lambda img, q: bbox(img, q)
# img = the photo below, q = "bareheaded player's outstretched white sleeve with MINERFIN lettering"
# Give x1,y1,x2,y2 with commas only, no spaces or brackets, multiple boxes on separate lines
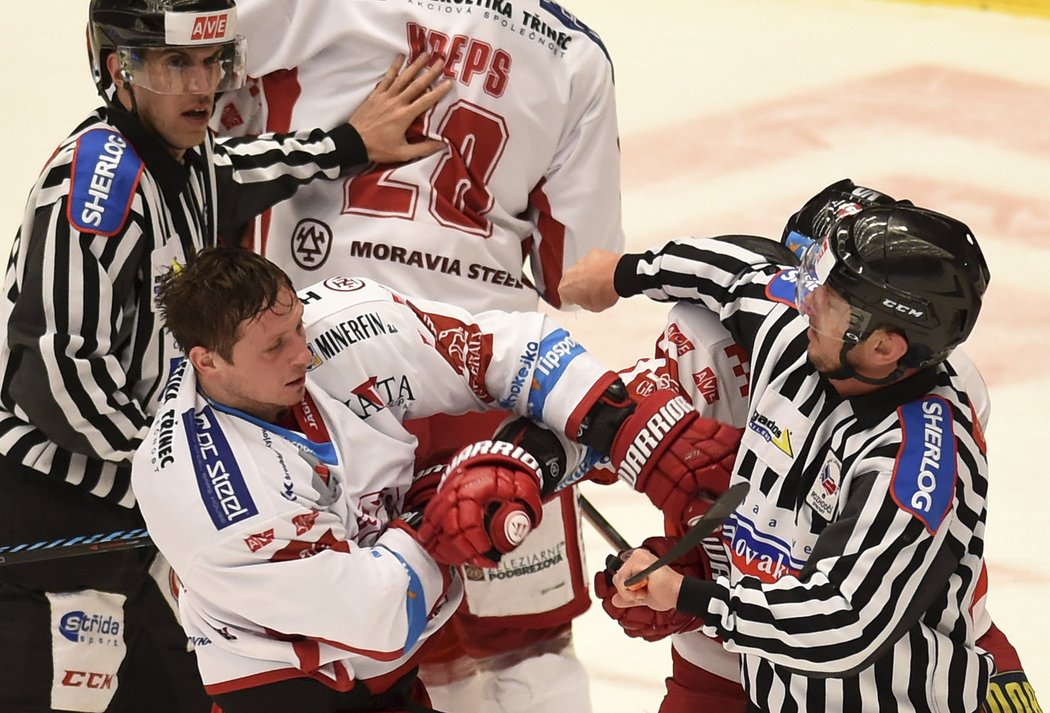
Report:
298,277,615,438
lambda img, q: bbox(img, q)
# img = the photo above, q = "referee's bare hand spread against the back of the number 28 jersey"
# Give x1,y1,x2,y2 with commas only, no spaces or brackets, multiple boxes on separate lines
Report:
350,53,453,164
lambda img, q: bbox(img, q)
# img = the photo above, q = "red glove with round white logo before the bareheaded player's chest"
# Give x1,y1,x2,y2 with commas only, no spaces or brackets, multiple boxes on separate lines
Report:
419,441,543,567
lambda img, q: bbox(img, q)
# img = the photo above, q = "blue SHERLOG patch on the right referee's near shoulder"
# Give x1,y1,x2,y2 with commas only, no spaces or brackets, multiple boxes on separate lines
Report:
890,395,958,533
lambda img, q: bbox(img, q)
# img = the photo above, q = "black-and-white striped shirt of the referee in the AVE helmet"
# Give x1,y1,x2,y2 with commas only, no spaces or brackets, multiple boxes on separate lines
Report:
0,108,366,507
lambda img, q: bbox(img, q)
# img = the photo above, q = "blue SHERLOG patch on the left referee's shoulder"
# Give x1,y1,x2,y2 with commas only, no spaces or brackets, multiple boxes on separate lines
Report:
67,129,144,237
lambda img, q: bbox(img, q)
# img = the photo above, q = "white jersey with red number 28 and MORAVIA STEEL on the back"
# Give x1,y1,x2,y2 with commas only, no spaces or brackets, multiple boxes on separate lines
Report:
213,0,624,312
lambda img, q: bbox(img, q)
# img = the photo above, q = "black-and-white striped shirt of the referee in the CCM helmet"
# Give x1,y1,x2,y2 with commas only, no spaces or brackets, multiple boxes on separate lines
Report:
616,238,991,713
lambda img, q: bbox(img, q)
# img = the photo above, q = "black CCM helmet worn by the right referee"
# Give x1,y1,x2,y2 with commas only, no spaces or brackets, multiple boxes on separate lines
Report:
814,203,990,368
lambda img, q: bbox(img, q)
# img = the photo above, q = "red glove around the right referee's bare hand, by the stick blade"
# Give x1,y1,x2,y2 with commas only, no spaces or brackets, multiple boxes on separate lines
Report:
594,538,711,642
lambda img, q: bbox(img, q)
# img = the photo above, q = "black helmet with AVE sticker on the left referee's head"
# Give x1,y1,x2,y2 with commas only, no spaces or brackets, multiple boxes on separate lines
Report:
87,0,245,101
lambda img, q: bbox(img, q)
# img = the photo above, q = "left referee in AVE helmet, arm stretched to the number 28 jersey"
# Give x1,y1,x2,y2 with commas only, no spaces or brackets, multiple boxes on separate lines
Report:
0,0,450,713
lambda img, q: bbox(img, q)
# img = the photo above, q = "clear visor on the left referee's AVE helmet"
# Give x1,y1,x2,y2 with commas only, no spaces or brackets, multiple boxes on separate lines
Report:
117,37,246,95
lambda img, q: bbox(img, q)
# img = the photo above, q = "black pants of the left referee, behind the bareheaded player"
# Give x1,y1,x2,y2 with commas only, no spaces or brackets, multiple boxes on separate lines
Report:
0,457,211,713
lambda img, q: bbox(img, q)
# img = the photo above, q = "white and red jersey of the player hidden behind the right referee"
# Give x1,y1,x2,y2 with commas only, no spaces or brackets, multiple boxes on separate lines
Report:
621,302,991,680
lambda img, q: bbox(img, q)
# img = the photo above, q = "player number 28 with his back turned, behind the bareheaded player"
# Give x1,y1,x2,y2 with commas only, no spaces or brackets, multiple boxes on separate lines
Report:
213,0,624,713
